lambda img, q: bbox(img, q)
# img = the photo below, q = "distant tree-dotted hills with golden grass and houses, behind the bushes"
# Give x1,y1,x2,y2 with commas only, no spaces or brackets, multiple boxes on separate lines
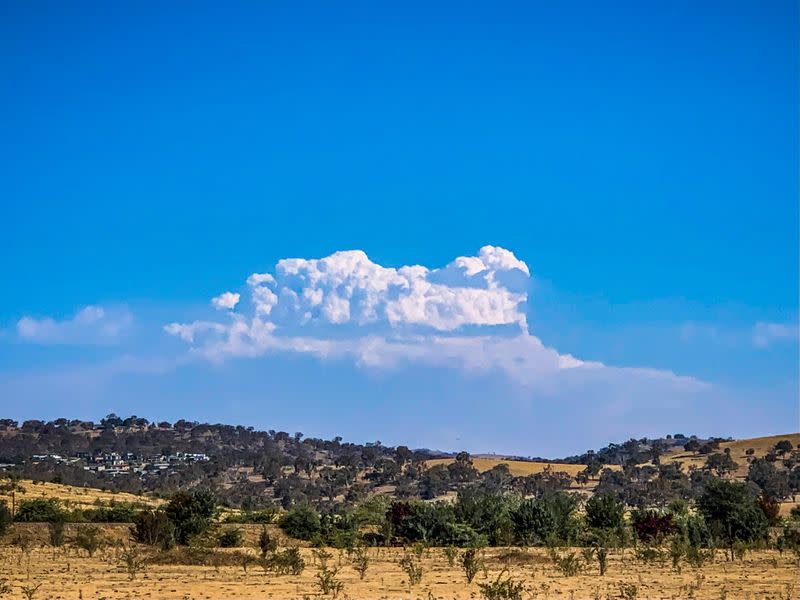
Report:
0,415,800,510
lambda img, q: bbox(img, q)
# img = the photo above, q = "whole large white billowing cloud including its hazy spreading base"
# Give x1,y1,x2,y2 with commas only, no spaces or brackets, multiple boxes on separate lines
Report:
165,246,704,385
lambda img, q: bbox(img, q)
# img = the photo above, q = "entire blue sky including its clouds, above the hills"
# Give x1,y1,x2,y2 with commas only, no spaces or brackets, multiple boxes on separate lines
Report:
0,1,800,454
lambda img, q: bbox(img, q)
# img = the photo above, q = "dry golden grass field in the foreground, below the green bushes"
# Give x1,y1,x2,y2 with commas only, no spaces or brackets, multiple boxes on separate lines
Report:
0,546,798,600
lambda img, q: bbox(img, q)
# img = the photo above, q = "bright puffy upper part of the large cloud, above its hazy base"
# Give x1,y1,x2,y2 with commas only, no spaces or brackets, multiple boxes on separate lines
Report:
248,246,530,332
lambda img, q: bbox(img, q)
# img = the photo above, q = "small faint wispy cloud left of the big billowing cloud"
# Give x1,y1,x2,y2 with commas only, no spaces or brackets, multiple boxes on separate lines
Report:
16,305,133,345
